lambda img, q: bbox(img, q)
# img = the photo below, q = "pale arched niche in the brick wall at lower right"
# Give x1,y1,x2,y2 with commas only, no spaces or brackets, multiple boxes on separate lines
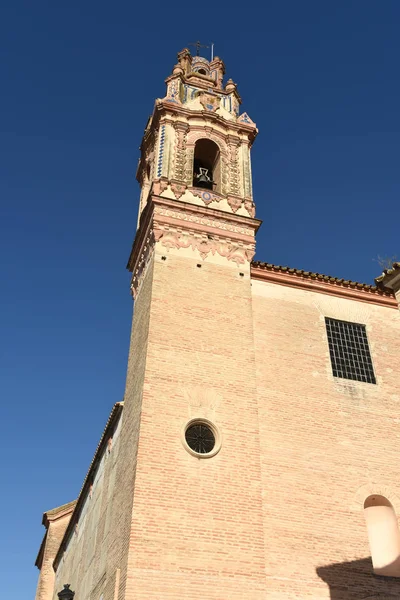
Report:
364,494,400,577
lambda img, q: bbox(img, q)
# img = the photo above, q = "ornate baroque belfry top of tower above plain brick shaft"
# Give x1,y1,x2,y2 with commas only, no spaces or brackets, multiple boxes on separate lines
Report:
128,49,258,286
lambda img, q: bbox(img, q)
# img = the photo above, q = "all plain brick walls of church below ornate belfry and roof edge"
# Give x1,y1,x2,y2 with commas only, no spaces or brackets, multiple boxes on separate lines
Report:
40,254,400,600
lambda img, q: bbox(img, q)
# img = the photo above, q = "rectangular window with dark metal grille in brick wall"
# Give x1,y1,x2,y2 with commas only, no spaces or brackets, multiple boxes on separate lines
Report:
325,317,376,383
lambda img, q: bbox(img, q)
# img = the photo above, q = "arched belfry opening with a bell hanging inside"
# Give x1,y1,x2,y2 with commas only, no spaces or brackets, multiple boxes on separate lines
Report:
193,138,221,192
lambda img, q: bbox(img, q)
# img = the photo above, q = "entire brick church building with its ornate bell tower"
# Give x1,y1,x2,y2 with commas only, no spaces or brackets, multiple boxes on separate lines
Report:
36,49,400,600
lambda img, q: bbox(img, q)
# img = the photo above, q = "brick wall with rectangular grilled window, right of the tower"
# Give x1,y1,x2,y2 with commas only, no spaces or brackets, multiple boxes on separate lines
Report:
252,281,400,600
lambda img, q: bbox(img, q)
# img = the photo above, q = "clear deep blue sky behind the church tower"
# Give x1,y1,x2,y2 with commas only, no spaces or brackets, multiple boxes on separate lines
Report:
0,0,400,600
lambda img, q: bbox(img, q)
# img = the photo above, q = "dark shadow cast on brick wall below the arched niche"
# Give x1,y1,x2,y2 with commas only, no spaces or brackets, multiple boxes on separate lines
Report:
317,558,400,600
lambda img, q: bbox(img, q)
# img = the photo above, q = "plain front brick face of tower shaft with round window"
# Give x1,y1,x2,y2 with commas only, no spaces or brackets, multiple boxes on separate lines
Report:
125,247,265,600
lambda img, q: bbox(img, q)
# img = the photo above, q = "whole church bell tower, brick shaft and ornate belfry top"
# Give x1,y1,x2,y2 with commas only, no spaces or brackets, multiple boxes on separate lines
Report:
120,49,265,600
